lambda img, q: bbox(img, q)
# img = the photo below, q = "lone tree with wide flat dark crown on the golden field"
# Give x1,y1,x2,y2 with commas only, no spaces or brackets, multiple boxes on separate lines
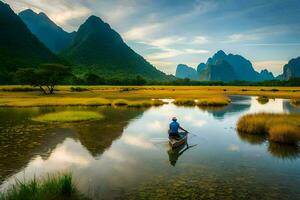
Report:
16,64,72,94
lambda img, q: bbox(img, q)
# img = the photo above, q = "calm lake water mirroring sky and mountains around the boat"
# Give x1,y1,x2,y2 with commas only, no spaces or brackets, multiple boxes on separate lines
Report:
0,96,300,199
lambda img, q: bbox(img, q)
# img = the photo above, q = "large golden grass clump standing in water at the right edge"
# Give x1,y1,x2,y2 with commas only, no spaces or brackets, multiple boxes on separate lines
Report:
237,113,300,144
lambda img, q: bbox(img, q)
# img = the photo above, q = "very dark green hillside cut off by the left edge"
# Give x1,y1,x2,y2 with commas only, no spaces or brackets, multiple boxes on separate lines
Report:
0,1,61,83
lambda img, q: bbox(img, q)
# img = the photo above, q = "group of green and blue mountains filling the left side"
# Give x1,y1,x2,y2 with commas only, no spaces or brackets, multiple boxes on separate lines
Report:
0,1,169,83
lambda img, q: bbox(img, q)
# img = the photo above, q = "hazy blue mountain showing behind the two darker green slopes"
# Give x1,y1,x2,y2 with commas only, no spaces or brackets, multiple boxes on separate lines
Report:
19,9,76,53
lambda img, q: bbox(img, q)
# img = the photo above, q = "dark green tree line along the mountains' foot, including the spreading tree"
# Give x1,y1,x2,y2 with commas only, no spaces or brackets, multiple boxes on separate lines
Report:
0,64,300,94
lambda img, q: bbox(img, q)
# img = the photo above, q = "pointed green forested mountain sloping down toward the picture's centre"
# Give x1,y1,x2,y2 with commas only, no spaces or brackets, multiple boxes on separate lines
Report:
61,16,168,80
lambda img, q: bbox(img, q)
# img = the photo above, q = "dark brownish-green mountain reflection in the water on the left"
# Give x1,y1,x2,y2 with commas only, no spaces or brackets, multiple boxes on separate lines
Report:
0,108,144,182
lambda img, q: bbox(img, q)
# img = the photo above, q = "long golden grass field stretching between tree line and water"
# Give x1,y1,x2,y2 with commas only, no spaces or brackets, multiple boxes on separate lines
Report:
0,86,300,107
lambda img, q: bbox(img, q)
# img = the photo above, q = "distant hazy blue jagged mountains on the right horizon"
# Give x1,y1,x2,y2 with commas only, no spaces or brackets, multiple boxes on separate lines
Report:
176,50,300,81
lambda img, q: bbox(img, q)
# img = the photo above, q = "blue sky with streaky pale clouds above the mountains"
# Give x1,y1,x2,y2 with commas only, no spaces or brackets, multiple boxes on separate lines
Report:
4,0,300,75
